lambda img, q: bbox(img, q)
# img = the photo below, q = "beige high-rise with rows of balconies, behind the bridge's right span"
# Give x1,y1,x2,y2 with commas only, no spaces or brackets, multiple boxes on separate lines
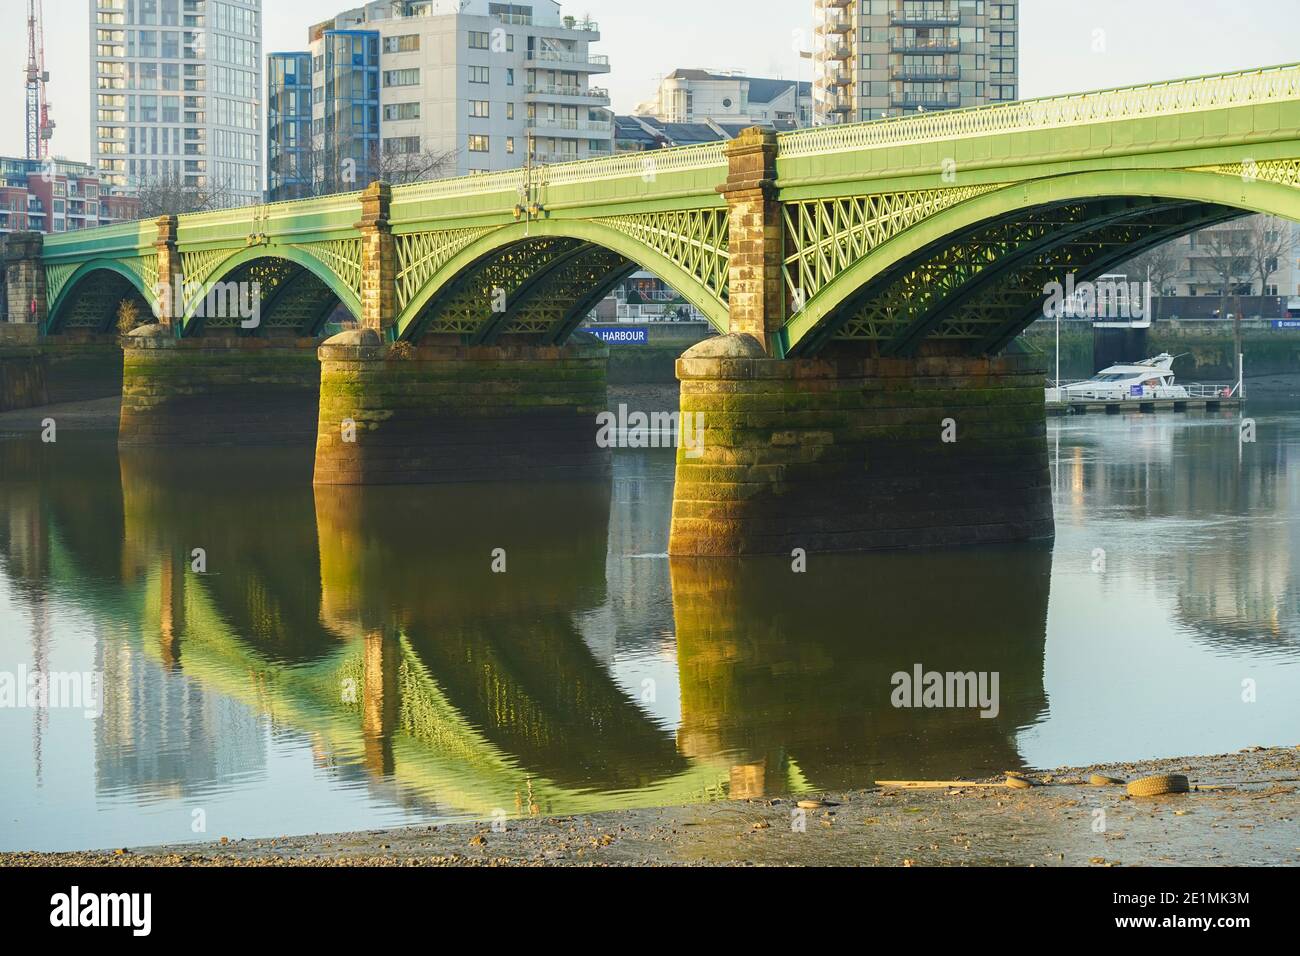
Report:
813,0,1019,124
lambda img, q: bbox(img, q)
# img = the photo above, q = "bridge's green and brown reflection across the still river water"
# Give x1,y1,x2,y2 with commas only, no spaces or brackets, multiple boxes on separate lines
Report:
0,442,1050,818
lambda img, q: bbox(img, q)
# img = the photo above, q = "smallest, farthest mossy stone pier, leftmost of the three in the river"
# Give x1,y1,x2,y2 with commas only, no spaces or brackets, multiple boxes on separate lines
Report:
118,325,320,445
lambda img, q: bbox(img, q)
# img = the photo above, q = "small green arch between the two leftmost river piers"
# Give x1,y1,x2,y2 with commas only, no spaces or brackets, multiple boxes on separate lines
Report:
181,245,361,337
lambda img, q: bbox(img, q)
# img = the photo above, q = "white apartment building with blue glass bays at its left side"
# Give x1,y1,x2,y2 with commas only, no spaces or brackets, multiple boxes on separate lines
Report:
267,0,614,200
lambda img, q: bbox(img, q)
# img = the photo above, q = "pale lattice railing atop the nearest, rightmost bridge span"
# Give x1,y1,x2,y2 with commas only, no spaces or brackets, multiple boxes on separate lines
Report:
779,64,1300,159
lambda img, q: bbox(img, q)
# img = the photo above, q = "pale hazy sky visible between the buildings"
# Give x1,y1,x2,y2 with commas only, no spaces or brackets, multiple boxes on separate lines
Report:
0,0,1300,160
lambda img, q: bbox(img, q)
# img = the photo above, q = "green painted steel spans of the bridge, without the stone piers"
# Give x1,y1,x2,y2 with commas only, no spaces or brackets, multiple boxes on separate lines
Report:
35,65,1300,356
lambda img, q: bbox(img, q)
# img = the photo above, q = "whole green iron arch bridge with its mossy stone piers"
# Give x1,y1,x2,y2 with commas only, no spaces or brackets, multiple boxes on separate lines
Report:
7,65,1300,554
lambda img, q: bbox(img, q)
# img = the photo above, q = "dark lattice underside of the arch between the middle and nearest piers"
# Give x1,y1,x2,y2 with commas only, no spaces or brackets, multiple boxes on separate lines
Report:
407,237,584,341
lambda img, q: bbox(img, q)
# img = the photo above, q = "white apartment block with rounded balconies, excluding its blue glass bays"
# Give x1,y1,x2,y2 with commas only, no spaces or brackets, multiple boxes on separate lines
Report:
311,0,614,174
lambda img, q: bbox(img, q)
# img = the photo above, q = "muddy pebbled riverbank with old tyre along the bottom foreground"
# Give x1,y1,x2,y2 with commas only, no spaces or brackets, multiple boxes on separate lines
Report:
0,747,1300,866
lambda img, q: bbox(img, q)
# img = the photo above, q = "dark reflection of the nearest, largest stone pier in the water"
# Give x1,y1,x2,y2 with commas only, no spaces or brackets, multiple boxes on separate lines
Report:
671,546,1052,796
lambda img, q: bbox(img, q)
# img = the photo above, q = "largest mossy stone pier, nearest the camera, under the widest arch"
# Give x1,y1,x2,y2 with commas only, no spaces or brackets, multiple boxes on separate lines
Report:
670,334,1053,555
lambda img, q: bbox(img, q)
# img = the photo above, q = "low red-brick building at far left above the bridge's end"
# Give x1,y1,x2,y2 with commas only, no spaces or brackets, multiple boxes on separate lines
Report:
0,156,139,233
